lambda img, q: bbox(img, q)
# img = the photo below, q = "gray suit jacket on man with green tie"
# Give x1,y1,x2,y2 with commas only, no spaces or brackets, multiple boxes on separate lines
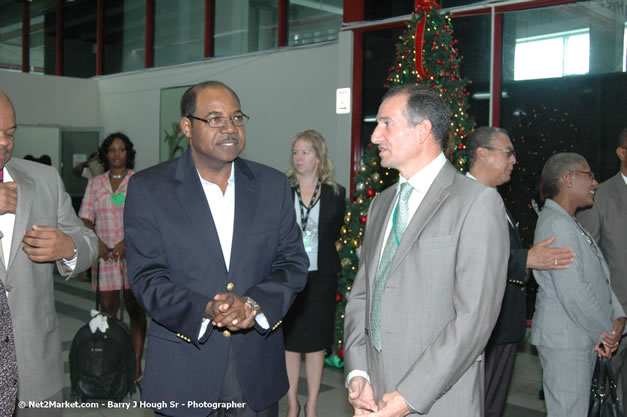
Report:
345,163,509,417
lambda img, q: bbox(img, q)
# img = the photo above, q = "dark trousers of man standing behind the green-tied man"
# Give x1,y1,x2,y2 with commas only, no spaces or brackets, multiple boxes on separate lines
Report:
485,343,518,417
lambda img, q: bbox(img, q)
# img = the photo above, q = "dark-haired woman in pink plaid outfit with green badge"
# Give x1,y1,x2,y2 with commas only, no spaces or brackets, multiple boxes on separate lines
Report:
78,132,146,379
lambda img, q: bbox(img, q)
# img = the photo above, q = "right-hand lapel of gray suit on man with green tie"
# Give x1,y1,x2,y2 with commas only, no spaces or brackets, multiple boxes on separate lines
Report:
390,163,457,274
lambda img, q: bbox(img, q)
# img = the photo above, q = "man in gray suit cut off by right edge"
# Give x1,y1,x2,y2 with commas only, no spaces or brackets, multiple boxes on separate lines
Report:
577,128,627,401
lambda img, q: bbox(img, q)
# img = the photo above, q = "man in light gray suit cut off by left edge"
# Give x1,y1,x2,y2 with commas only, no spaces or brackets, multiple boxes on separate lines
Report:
0,91,98,417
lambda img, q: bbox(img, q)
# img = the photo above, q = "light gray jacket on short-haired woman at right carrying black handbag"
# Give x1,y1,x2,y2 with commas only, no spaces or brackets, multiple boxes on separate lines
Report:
531,199,625,350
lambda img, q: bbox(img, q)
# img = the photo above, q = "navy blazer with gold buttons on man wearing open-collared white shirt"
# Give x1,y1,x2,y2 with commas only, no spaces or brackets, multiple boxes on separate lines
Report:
124,150,309,416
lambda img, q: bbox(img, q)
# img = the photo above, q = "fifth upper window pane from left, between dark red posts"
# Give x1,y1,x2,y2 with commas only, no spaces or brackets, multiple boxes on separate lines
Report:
154,0,205,67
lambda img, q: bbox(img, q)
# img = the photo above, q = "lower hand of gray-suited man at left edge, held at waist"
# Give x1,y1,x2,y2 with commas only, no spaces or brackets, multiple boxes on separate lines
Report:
22,226,75,262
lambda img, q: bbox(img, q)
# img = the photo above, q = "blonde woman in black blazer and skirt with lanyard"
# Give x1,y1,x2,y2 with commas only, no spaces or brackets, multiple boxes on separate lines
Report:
283,130,346,417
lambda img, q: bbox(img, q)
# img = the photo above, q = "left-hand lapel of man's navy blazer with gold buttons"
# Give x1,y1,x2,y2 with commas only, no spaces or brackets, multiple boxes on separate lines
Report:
174,150,226,272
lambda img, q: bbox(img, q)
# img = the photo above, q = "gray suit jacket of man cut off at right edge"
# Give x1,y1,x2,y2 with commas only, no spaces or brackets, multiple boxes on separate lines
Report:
577,172,627,310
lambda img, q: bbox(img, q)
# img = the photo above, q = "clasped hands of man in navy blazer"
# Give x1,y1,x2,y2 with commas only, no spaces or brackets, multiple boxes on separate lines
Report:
205,293,257,331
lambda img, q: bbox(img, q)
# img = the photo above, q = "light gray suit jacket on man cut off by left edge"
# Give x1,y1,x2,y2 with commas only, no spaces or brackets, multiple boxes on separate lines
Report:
0,158,98,401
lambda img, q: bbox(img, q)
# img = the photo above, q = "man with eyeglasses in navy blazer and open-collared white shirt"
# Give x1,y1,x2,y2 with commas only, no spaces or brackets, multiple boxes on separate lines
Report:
124,81,308,417
